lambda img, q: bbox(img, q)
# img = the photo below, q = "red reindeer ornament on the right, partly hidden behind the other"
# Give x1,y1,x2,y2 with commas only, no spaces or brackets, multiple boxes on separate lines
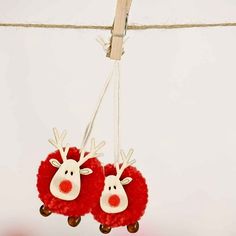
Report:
92,149,148,234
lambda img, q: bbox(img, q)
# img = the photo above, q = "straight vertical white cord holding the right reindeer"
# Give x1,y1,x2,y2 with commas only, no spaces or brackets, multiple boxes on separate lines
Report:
114,61,121,163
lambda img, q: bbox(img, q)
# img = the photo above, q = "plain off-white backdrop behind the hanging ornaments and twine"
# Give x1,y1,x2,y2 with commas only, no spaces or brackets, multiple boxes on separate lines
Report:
0,0,236,236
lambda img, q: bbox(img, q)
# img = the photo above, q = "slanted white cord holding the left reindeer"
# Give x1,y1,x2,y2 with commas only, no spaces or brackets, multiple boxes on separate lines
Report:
81,62,117,154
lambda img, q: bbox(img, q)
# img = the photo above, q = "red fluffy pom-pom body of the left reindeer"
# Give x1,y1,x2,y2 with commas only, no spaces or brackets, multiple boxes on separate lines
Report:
37,147,104,217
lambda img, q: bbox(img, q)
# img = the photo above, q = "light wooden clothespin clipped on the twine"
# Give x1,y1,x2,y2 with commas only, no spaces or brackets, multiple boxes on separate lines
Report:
107,0,132,60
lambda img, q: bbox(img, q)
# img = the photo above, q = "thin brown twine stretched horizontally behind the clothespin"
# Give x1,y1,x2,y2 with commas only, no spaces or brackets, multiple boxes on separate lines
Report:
0,22,236,30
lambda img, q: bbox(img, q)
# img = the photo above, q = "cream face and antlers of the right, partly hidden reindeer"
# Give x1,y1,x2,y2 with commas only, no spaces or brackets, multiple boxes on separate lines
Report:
100,149,135,213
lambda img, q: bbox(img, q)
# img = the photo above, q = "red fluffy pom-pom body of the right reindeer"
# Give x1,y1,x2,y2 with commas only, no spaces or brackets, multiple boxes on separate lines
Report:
92,164,148,228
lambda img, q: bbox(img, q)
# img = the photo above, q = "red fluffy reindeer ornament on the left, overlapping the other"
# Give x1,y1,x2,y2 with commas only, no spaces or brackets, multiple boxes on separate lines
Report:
37,129,105,226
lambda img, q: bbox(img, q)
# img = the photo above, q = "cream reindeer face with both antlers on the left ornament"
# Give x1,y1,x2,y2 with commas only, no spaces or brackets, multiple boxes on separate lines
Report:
49,129,105,201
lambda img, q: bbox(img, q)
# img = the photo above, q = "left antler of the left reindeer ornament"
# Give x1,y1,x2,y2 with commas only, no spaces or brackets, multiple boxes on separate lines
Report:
48,128,69,162
